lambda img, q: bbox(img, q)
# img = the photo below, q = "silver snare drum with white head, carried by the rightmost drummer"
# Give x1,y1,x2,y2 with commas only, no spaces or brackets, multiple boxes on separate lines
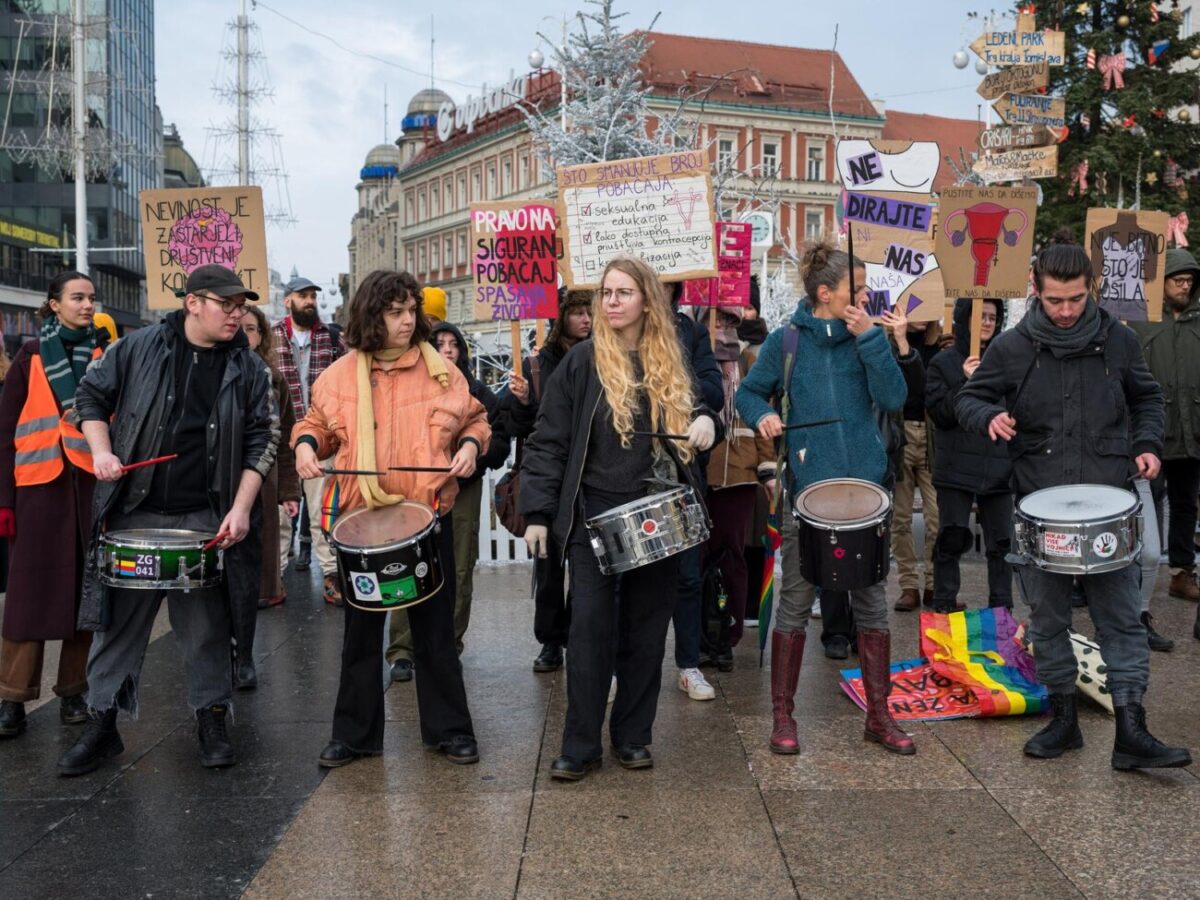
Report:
1013,485,1141,575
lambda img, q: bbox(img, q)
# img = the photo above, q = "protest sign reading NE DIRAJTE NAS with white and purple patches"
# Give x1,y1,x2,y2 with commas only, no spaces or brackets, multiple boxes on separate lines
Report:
838,139,943,322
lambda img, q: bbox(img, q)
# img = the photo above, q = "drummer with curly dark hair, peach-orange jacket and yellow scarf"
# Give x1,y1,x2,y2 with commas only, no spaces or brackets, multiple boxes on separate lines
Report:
292,270,492,768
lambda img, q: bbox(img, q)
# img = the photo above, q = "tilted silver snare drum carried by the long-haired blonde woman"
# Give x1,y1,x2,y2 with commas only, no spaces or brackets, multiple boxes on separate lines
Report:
584,485,708,575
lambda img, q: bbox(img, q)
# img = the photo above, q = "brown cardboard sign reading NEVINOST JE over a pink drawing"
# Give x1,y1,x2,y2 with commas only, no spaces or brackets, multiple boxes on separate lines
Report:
138,185,268,310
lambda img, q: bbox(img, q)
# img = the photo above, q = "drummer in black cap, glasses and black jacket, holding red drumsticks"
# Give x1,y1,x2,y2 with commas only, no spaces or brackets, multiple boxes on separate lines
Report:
59,265,280,775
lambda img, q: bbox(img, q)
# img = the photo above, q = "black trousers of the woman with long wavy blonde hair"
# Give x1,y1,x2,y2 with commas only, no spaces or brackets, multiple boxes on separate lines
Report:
563,527,679,761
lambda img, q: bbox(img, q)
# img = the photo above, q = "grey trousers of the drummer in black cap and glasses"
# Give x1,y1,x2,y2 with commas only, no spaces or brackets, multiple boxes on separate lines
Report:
88,510,233,719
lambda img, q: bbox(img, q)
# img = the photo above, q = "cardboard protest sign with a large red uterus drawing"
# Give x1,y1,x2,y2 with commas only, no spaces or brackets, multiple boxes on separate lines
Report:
937,186,1038,300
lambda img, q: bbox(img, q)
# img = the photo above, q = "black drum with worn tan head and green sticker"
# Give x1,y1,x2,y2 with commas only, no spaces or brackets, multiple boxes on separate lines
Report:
329,500,442,612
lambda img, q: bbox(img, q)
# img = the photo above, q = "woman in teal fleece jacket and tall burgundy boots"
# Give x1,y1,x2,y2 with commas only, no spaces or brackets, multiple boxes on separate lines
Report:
737,242,917,755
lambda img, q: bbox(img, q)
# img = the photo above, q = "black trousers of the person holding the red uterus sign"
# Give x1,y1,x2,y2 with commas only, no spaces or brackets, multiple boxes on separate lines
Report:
934,487,1013,612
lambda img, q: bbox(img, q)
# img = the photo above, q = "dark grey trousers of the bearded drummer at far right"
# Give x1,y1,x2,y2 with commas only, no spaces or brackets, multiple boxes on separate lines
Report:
1015,563,1150,706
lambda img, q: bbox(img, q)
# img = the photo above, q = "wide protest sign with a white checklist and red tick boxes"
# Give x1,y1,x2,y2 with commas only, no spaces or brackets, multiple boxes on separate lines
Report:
558,150,716,288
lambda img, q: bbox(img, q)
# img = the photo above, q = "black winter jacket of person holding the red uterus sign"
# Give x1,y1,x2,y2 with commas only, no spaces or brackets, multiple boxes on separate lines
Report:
925,300,1013,496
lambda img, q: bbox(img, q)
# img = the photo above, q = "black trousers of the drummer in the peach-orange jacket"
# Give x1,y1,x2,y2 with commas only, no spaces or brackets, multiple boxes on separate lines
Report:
334,515,474,754
